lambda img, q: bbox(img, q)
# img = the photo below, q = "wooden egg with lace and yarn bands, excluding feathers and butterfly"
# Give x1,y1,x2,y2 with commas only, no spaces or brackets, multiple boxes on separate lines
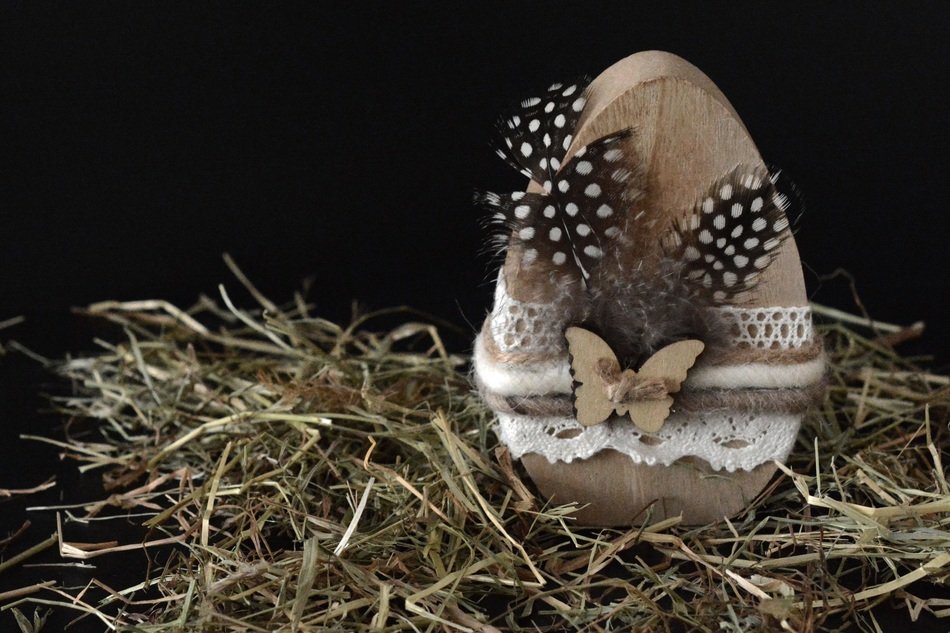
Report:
475,51,823,526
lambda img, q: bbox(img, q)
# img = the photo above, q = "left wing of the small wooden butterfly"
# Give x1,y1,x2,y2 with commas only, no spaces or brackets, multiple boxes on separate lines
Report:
564,327,620,426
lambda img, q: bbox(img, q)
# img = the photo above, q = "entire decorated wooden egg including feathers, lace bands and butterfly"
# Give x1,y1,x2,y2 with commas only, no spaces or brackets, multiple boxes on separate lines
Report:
474,51,824,526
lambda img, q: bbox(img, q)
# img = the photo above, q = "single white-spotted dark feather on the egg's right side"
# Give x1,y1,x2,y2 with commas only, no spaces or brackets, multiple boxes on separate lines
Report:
666,166,791,303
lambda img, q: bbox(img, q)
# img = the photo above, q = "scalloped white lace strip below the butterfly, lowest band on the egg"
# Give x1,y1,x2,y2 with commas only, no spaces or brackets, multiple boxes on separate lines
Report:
496,413,802,472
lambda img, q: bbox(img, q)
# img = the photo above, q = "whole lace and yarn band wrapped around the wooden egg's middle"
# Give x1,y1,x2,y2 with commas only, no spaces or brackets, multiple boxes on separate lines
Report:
473,274,825,471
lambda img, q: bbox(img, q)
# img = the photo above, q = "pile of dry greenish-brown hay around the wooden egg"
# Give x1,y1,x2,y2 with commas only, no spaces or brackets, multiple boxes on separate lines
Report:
0,262,950,632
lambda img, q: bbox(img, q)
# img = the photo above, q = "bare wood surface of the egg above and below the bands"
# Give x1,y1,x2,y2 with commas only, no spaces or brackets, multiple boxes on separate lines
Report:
504,51,807,525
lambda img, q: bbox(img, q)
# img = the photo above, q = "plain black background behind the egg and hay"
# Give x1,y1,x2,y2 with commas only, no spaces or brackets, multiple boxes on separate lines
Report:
0,2,950,626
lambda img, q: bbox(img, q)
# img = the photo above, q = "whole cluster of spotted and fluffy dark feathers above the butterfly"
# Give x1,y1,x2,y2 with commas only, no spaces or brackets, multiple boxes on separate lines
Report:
476,82,790,366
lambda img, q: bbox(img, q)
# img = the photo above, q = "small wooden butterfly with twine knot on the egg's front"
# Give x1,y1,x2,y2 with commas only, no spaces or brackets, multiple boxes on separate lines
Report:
565,327,705,433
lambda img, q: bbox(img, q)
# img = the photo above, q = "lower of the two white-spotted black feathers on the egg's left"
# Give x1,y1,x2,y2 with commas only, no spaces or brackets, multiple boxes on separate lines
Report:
480,131,639,287
